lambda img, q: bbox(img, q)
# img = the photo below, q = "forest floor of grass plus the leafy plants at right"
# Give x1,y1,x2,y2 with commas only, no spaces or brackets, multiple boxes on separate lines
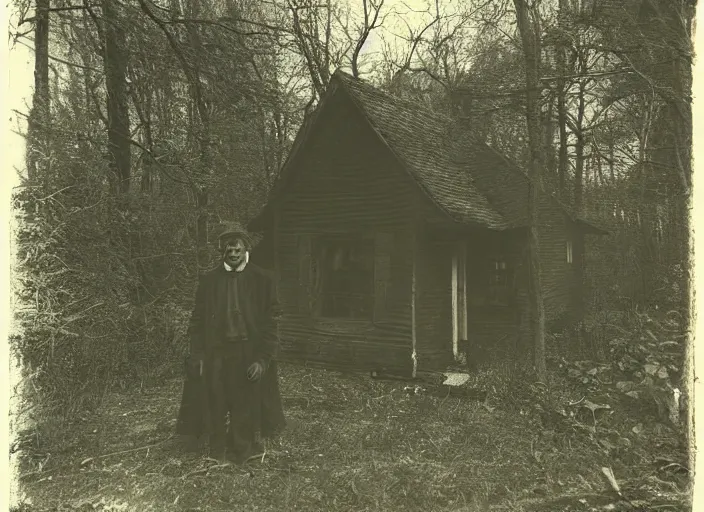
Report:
14,306,691,512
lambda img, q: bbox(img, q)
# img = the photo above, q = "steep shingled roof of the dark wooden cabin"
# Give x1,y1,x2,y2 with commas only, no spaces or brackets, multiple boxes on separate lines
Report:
250,70,604,230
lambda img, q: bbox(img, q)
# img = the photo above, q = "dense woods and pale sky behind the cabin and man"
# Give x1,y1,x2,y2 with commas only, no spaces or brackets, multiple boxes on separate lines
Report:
12,0,695,426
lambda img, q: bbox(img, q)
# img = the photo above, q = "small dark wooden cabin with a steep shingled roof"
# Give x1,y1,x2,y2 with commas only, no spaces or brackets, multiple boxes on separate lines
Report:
249,71,598,372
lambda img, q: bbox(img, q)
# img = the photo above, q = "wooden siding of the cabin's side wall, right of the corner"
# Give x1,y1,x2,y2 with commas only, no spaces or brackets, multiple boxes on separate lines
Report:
410,195,573,369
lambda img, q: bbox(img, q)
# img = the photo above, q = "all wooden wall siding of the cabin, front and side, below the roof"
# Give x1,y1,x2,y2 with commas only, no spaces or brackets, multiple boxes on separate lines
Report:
262,89,571,371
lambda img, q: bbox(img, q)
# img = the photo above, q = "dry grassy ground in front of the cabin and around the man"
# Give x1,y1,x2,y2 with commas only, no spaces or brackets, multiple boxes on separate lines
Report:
13,365,689,512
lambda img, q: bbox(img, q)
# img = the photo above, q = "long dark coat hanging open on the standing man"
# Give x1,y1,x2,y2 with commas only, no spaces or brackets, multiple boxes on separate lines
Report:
176,263,285,437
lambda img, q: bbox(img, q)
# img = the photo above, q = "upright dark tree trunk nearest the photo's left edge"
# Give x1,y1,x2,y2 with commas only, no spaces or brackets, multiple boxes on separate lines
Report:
26,0,51,186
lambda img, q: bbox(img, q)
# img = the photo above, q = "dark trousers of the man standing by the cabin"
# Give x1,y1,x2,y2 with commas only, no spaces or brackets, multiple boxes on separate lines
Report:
210,342,261,457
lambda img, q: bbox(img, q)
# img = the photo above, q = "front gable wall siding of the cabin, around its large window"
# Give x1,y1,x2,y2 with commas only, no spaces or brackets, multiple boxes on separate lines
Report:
276,91,416,371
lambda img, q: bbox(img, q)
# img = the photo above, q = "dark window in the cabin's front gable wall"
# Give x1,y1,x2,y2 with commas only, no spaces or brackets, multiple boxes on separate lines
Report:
312,236,374,320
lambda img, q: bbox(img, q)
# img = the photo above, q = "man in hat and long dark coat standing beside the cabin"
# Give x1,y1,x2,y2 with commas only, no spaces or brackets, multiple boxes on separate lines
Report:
177,223,285,463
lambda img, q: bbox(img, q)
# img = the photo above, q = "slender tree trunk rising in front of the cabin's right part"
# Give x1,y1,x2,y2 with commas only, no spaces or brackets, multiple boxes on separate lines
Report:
513,0,547,383
